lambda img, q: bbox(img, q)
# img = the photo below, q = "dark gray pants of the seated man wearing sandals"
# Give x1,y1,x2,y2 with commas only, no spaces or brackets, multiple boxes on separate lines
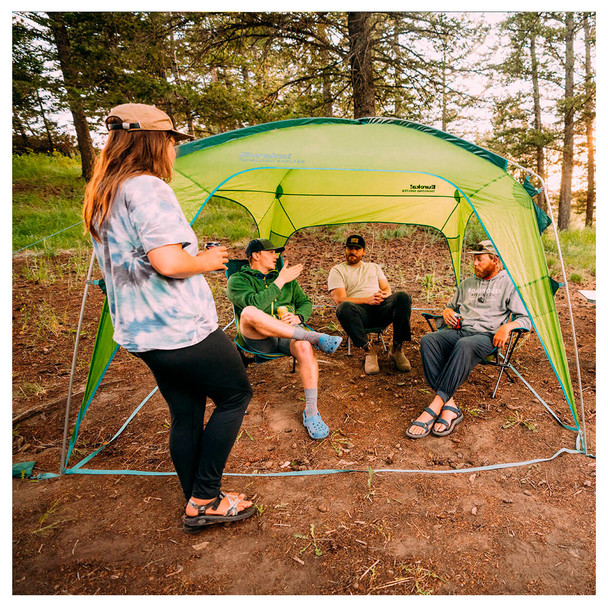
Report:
420,329,494,403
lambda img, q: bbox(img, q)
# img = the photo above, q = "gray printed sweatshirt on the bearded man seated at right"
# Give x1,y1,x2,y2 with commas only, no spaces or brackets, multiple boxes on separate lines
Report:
448,270,532,333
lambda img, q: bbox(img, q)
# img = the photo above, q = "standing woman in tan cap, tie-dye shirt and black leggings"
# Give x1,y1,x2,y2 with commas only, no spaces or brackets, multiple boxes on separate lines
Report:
83,104,255,532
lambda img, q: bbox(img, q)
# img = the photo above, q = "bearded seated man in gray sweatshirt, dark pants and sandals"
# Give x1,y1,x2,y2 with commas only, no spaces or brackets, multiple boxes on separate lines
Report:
405,241,532,439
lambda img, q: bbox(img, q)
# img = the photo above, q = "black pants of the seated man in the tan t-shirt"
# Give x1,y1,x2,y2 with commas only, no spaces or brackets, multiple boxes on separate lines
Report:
336,291,412,348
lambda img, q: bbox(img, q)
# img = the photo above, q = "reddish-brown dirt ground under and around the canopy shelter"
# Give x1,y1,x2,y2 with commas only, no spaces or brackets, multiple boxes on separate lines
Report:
12,226,596,595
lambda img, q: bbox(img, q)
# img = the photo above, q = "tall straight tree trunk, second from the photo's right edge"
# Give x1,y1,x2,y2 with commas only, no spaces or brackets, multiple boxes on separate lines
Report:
557,12,574,230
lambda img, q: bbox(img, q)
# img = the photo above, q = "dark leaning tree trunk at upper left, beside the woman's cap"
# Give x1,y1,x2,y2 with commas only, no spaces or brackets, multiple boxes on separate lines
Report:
50,13,95,181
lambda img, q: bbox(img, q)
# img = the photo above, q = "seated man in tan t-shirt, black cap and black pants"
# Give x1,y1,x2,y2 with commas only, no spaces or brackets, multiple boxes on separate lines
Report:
327,234,412,374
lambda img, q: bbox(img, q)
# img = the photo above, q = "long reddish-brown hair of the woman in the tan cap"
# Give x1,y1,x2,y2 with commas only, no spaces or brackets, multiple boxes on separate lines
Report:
82,119,173,241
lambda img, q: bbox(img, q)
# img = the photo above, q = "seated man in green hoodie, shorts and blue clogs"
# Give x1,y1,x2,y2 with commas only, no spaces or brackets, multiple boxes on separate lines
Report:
226,239,342,439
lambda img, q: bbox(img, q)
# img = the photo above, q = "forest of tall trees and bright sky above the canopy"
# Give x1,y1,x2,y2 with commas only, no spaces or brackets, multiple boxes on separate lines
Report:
12,11,596,230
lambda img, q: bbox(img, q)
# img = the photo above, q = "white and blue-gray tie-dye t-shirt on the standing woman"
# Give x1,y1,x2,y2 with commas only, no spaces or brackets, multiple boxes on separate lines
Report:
93,175,218,352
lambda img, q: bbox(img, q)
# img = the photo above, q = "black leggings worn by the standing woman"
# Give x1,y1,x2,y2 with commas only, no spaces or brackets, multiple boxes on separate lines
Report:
138,329,252,499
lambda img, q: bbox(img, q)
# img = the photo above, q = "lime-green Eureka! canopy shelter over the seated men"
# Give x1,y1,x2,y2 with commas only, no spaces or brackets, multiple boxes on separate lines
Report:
62,118,584,476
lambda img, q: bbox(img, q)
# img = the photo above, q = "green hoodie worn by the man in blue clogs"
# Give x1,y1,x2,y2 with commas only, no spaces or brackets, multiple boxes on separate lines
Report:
226,265,312,323
